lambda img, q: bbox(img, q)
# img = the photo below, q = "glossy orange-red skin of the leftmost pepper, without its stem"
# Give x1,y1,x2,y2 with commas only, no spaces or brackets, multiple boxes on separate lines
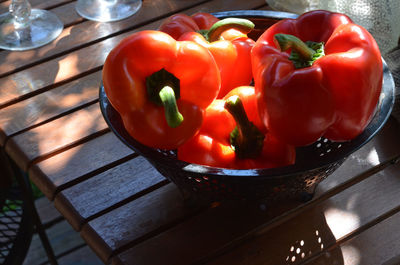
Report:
103,31,220,149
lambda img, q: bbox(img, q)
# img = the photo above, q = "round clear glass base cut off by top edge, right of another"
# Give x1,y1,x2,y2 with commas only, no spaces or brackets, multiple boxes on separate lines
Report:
76,0,142,22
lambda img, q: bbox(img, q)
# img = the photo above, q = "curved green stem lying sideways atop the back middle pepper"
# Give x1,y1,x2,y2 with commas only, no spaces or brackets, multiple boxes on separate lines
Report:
202,18,254,42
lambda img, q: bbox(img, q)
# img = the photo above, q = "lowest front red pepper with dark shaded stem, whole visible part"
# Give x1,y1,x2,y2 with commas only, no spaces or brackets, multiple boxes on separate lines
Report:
178,87,296,169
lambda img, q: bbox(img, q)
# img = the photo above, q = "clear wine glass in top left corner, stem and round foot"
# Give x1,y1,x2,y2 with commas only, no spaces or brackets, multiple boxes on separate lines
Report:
0,0,64,51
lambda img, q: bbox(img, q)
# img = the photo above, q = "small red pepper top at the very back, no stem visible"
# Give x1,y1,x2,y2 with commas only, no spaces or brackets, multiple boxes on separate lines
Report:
158,12,219,40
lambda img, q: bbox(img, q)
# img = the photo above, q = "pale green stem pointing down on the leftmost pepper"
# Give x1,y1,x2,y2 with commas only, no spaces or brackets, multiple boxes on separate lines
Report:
159,86,183,128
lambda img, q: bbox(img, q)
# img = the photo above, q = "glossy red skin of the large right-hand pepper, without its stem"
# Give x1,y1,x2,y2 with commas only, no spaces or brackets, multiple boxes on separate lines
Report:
252,10,383,146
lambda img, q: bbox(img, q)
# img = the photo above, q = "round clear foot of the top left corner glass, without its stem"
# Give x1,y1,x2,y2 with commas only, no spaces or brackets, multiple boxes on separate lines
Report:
0,9,64,51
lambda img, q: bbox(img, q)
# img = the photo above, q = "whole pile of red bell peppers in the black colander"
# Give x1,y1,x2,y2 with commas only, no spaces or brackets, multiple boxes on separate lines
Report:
103,10,383,169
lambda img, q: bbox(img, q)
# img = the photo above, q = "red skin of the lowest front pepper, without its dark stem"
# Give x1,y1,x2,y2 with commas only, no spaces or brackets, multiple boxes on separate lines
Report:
178,87,296,169
